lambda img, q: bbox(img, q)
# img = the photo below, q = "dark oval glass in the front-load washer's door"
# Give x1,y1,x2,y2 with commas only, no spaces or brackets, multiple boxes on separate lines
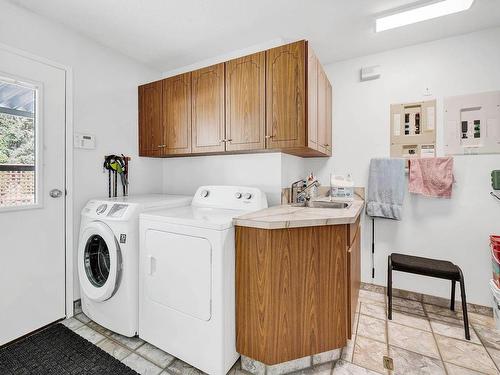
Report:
84,234,111,288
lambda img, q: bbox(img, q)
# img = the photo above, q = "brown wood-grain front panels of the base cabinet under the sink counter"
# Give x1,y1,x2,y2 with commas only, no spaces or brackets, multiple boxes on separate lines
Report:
236,225,359,365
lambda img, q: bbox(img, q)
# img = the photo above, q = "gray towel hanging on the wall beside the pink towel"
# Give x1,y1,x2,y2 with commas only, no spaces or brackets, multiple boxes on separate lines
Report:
366,159,405,220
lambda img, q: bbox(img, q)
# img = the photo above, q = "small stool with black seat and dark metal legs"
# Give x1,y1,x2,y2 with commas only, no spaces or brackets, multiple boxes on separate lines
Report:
387,253,470,340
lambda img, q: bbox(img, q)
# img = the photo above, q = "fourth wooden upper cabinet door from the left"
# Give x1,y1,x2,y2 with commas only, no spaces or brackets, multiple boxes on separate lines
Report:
226,52,266,151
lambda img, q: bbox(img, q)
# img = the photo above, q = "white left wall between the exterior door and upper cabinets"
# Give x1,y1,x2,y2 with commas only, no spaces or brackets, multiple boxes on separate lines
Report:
0,0,162,299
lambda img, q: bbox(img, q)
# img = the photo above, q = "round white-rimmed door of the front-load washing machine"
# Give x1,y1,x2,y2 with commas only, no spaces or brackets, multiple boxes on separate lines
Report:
78,221,121,302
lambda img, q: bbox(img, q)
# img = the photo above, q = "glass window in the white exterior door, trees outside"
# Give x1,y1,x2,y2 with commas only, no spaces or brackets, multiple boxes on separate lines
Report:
0,78,37,209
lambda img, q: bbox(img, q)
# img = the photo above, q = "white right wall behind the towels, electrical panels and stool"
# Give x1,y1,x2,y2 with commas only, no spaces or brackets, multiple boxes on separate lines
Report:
305,28,500,305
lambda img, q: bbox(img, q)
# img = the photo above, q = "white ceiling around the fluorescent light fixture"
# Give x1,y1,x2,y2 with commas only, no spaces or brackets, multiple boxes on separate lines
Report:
9,0,500,72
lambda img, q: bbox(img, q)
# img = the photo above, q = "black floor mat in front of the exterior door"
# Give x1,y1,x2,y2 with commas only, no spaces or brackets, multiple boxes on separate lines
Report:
0,324,138,375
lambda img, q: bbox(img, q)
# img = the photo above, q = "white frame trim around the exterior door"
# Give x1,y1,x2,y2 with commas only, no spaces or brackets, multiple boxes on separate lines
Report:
0,43,74,318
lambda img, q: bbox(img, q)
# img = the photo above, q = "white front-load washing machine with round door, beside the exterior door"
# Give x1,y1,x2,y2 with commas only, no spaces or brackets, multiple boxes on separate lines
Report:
77,194,192,337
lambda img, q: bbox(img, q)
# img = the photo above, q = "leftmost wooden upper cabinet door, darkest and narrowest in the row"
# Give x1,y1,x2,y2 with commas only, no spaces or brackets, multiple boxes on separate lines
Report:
139,81,165,156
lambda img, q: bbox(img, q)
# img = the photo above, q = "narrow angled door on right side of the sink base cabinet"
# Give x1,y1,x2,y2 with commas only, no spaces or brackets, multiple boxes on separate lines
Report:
347,225,361,336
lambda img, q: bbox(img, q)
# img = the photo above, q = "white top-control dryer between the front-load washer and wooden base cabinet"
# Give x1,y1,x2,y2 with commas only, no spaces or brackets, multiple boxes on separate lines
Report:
139,186,267,375
